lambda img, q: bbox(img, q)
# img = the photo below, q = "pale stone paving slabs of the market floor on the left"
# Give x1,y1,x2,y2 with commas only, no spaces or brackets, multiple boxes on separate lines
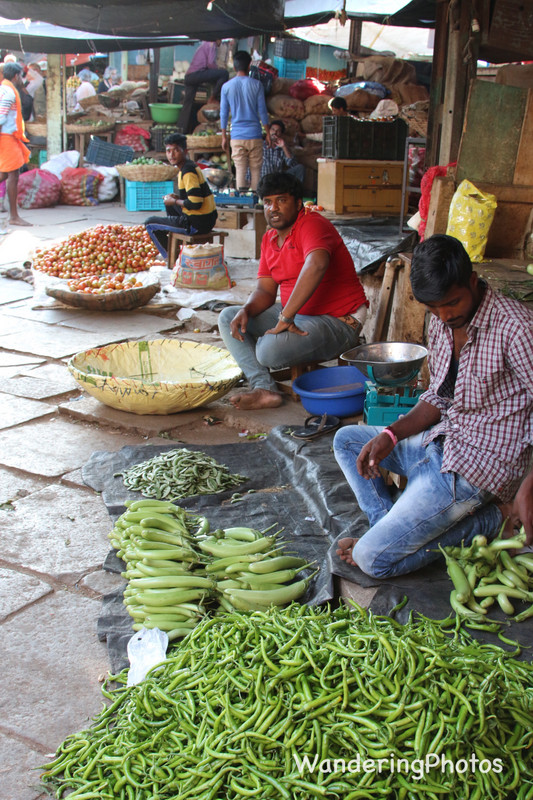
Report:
0,203,314,800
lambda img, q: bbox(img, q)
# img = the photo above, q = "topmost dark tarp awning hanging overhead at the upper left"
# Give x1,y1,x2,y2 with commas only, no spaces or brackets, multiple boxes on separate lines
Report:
0,0,285,39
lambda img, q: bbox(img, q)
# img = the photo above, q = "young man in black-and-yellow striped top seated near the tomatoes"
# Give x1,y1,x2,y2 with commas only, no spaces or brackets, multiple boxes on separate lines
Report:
144,133,217,260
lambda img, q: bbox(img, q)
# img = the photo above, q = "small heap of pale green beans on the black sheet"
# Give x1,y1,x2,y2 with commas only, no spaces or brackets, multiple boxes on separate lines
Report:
114,447,247,500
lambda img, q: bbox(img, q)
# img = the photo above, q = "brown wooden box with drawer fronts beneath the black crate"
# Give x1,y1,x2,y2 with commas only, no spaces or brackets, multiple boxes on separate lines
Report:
317,158,403,216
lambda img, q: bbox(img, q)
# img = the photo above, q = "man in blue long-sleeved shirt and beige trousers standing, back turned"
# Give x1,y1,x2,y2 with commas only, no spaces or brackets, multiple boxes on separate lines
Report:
220,50,270,191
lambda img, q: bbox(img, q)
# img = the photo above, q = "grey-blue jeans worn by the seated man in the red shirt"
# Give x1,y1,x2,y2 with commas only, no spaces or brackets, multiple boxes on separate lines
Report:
218,303,359,392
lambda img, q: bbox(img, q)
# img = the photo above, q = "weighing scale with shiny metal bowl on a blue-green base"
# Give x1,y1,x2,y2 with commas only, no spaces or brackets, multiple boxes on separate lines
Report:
341,342,428,425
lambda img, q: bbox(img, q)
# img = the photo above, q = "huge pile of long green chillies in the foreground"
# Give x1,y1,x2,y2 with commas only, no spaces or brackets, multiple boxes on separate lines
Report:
42,604,533,800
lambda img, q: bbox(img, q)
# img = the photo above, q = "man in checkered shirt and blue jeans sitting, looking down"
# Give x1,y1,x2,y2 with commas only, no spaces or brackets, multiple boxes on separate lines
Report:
334,235,533,578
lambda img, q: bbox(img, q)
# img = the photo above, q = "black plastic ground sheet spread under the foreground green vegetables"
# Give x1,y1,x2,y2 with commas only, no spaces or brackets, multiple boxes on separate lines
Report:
82,427,533,671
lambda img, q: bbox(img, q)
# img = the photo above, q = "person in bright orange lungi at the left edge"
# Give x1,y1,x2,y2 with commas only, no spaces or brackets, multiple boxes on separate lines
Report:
0,63,31,225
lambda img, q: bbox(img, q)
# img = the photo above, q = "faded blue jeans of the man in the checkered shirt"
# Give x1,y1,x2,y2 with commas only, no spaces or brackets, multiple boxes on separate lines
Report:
333,425,502,578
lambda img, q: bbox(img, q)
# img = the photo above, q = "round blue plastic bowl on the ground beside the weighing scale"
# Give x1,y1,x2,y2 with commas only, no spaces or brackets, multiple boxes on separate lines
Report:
292,367,367,417
